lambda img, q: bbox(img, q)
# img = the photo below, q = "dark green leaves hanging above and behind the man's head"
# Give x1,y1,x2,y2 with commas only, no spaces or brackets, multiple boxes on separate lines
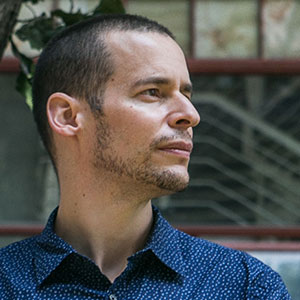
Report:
10,0,125,109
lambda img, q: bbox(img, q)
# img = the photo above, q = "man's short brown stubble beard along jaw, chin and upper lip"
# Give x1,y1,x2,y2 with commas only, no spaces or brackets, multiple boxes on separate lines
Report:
93,116,189,195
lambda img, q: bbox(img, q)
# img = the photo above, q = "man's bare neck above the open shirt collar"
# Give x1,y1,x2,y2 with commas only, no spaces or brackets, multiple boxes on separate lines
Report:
55,170,152,282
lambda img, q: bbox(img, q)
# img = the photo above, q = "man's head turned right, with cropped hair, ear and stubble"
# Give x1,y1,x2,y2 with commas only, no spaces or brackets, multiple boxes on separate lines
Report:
34,15,199,195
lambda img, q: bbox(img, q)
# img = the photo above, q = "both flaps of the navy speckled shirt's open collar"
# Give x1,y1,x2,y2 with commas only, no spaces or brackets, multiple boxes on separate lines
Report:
34,206,185,285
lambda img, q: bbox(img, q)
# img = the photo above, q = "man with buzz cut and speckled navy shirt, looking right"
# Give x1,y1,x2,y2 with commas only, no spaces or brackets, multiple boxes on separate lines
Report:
0,15,290,300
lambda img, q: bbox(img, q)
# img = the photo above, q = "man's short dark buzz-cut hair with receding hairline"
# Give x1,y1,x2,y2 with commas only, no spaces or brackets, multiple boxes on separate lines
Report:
32,14,174,166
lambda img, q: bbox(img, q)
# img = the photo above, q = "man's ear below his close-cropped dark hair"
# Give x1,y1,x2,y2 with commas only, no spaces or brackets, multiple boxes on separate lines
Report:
47,93,80,136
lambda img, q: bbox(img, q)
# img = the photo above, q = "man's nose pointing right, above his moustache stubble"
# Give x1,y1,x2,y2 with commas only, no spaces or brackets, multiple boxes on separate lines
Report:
168,94,200,129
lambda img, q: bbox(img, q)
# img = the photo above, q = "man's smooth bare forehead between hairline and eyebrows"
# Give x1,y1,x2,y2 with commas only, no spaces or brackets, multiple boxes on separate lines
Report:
107,31,190,83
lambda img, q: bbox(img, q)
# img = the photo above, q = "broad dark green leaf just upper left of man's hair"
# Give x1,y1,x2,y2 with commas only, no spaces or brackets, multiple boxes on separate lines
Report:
16,14,58,50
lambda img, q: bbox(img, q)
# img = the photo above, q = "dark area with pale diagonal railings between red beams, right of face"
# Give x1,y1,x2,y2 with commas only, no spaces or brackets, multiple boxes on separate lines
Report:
158,76,300,226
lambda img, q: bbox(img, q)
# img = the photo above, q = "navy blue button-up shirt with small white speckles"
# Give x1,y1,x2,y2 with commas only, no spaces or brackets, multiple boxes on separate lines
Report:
0,209,291,300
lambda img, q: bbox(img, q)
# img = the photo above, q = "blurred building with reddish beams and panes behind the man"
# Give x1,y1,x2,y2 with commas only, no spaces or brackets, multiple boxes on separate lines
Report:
0,0,300,300
